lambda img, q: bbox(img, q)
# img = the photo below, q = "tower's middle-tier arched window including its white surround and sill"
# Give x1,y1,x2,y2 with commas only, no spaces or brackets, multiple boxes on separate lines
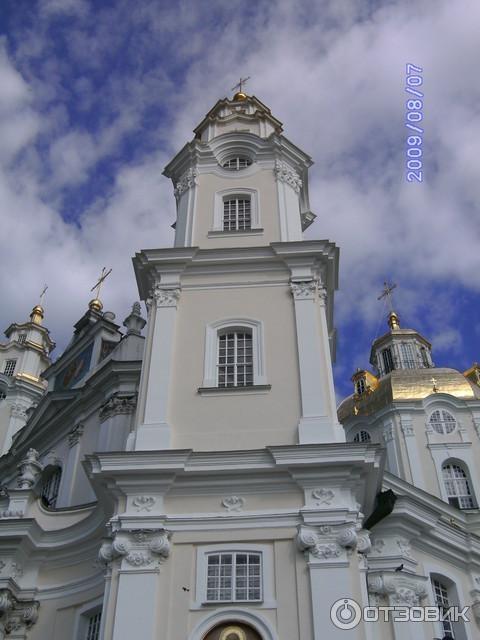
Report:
199,318,268,392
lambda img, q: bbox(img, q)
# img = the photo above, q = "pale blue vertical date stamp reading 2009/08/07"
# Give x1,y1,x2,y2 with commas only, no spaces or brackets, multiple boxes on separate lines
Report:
405,62,424,182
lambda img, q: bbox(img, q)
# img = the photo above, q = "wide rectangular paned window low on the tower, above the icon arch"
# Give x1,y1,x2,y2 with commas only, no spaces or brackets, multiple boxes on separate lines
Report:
206,551,262,602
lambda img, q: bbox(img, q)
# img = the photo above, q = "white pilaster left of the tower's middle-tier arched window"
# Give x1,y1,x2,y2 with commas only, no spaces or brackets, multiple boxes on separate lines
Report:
134,285,180,451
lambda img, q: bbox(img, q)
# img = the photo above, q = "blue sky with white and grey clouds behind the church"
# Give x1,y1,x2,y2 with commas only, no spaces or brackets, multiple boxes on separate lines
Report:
0,0,480,395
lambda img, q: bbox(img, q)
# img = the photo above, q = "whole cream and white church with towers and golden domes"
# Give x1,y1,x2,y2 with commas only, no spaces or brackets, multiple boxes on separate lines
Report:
0,86,480,640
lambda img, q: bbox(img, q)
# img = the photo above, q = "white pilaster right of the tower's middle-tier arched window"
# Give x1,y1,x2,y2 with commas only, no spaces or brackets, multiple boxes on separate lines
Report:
291,280,345,444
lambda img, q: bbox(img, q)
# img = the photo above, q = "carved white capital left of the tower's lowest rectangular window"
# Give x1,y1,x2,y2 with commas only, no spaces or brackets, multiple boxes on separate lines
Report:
98,529,172,569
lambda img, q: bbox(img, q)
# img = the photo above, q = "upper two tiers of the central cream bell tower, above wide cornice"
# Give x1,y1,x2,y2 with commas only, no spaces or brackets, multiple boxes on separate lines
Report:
130,91,344,450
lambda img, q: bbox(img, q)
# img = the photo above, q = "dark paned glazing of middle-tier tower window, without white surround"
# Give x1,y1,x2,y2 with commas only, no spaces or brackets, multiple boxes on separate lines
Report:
217,331,253,387
